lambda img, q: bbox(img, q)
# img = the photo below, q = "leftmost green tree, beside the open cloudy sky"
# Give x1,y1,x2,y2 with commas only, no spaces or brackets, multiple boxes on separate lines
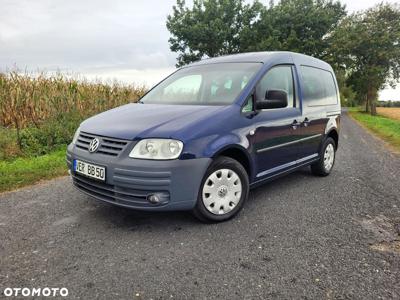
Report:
167,0,263,66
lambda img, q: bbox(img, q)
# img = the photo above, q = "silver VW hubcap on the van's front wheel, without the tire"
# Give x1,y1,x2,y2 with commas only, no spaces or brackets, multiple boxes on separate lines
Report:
202,169,242,215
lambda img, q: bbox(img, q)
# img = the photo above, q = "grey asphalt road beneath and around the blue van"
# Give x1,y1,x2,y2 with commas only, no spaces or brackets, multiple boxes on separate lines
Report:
0,116,400,299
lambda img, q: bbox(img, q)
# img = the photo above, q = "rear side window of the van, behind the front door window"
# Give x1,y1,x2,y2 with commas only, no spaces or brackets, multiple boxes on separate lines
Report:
301,66,338,106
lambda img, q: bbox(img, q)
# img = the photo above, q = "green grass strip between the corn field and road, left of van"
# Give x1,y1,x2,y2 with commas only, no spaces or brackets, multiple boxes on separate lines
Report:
0,147,67,193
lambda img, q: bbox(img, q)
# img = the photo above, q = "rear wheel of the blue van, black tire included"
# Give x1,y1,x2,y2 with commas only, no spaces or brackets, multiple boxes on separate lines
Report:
311,137,336,176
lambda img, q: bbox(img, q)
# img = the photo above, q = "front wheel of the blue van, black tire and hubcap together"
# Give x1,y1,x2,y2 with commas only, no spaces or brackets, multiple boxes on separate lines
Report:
193,156,249,223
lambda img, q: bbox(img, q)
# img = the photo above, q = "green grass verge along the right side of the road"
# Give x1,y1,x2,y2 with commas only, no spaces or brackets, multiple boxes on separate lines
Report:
349,109,400,152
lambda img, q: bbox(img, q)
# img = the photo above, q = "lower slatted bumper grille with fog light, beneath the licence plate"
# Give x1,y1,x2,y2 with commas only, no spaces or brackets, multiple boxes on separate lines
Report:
71,173,169,207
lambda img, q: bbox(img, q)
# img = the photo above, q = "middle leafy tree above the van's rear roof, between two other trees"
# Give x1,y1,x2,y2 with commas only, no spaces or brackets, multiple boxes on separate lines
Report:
250,0,346,61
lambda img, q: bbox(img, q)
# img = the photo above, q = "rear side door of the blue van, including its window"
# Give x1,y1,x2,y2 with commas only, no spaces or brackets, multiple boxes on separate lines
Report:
299,66,338,159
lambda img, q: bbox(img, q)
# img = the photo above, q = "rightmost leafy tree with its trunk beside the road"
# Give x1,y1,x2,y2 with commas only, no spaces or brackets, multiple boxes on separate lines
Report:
332,4,400,115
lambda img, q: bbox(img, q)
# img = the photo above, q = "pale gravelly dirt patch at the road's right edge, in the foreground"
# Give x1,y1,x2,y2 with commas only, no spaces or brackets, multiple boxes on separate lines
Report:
360,215,400,254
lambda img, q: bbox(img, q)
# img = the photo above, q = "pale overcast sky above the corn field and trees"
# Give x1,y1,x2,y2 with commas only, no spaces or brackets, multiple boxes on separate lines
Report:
0,0,400,100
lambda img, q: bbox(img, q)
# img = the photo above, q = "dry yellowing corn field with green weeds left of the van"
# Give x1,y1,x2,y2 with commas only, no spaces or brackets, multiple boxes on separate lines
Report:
0,71,146,160
